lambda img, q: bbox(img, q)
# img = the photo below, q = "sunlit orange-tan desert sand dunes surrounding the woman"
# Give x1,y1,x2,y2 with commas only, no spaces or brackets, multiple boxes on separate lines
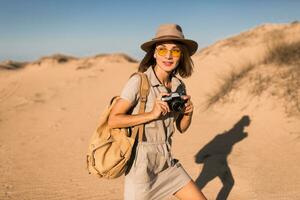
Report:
0,23,300,200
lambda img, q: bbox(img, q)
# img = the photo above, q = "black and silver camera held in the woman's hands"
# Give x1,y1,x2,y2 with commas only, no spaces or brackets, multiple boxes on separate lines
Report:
161,92,186,112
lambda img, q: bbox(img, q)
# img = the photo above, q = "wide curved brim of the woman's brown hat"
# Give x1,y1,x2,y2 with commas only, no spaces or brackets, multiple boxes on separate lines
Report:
141,38,198,56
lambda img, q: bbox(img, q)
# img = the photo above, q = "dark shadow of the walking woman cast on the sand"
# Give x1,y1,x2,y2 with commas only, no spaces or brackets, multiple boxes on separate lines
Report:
195,115,250,200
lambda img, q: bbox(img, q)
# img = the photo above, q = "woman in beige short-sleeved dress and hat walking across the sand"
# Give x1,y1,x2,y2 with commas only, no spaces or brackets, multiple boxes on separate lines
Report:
108,24,206,200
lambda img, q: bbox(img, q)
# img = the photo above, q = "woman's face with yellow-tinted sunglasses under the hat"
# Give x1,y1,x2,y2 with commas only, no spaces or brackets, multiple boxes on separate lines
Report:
154,42,182,73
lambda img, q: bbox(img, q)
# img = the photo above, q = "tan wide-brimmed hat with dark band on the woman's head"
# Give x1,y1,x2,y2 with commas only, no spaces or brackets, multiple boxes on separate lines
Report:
141,24,198,56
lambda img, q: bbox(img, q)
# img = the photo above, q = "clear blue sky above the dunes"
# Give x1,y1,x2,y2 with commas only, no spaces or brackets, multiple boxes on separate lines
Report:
0,0,300,61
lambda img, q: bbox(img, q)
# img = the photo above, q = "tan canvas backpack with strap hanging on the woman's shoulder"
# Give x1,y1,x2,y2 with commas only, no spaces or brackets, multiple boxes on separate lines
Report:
87,72,149,179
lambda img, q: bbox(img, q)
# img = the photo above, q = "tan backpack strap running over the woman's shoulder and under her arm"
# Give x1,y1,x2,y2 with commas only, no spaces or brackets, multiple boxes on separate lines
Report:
131,72,150,142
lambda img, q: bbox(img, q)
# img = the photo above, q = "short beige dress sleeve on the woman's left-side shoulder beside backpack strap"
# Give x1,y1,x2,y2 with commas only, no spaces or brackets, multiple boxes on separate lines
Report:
120,74,141,104
